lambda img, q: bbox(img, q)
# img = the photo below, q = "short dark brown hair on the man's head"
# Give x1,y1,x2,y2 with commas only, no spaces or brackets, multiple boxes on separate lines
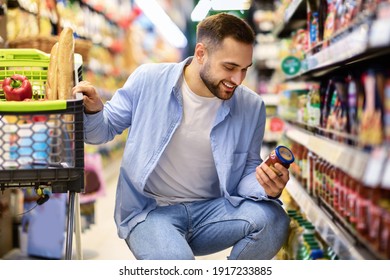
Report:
196,13,256,48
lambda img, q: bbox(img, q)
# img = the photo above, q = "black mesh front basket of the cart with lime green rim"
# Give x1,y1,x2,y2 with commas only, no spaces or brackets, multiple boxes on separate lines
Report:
0,100,84,192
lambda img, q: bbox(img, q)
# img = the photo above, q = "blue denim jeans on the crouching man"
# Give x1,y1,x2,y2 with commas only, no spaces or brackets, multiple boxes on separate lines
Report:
126,198,290,260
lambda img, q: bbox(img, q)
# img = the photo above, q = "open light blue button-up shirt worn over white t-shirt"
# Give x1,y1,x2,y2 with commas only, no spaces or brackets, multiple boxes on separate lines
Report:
84,57,268,238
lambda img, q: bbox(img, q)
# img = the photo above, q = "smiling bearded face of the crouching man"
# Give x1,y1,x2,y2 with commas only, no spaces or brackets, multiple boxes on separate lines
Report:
199,38,253,100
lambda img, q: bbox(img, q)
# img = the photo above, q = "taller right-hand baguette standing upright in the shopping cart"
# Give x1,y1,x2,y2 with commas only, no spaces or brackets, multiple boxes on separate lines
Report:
57,27,75,100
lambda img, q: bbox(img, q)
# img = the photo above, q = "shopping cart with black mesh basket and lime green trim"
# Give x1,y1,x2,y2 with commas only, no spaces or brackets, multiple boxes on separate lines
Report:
0,49,84,259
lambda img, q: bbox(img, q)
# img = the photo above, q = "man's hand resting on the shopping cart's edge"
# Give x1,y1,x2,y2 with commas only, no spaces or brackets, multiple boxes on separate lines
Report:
72,81,104,114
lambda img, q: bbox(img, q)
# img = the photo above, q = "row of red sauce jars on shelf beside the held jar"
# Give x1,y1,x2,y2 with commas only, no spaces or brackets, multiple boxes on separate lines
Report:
284,137,390,258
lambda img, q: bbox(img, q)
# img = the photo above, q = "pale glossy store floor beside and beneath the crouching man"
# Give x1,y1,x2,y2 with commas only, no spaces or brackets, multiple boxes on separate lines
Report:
80,155,230,260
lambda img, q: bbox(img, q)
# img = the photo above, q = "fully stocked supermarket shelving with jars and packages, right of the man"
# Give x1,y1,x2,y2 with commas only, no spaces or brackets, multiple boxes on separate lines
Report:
276,0,390,259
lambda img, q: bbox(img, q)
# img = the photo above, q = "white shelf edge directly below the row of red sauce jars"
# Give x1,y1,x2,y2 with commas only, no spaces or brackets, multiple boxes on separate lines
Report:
286,177,376,260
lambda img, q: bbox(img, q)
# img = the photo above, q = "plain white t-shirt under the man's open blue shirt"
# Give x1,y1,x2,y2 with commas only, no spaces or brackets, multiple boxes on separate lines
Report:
145,78,222,205
